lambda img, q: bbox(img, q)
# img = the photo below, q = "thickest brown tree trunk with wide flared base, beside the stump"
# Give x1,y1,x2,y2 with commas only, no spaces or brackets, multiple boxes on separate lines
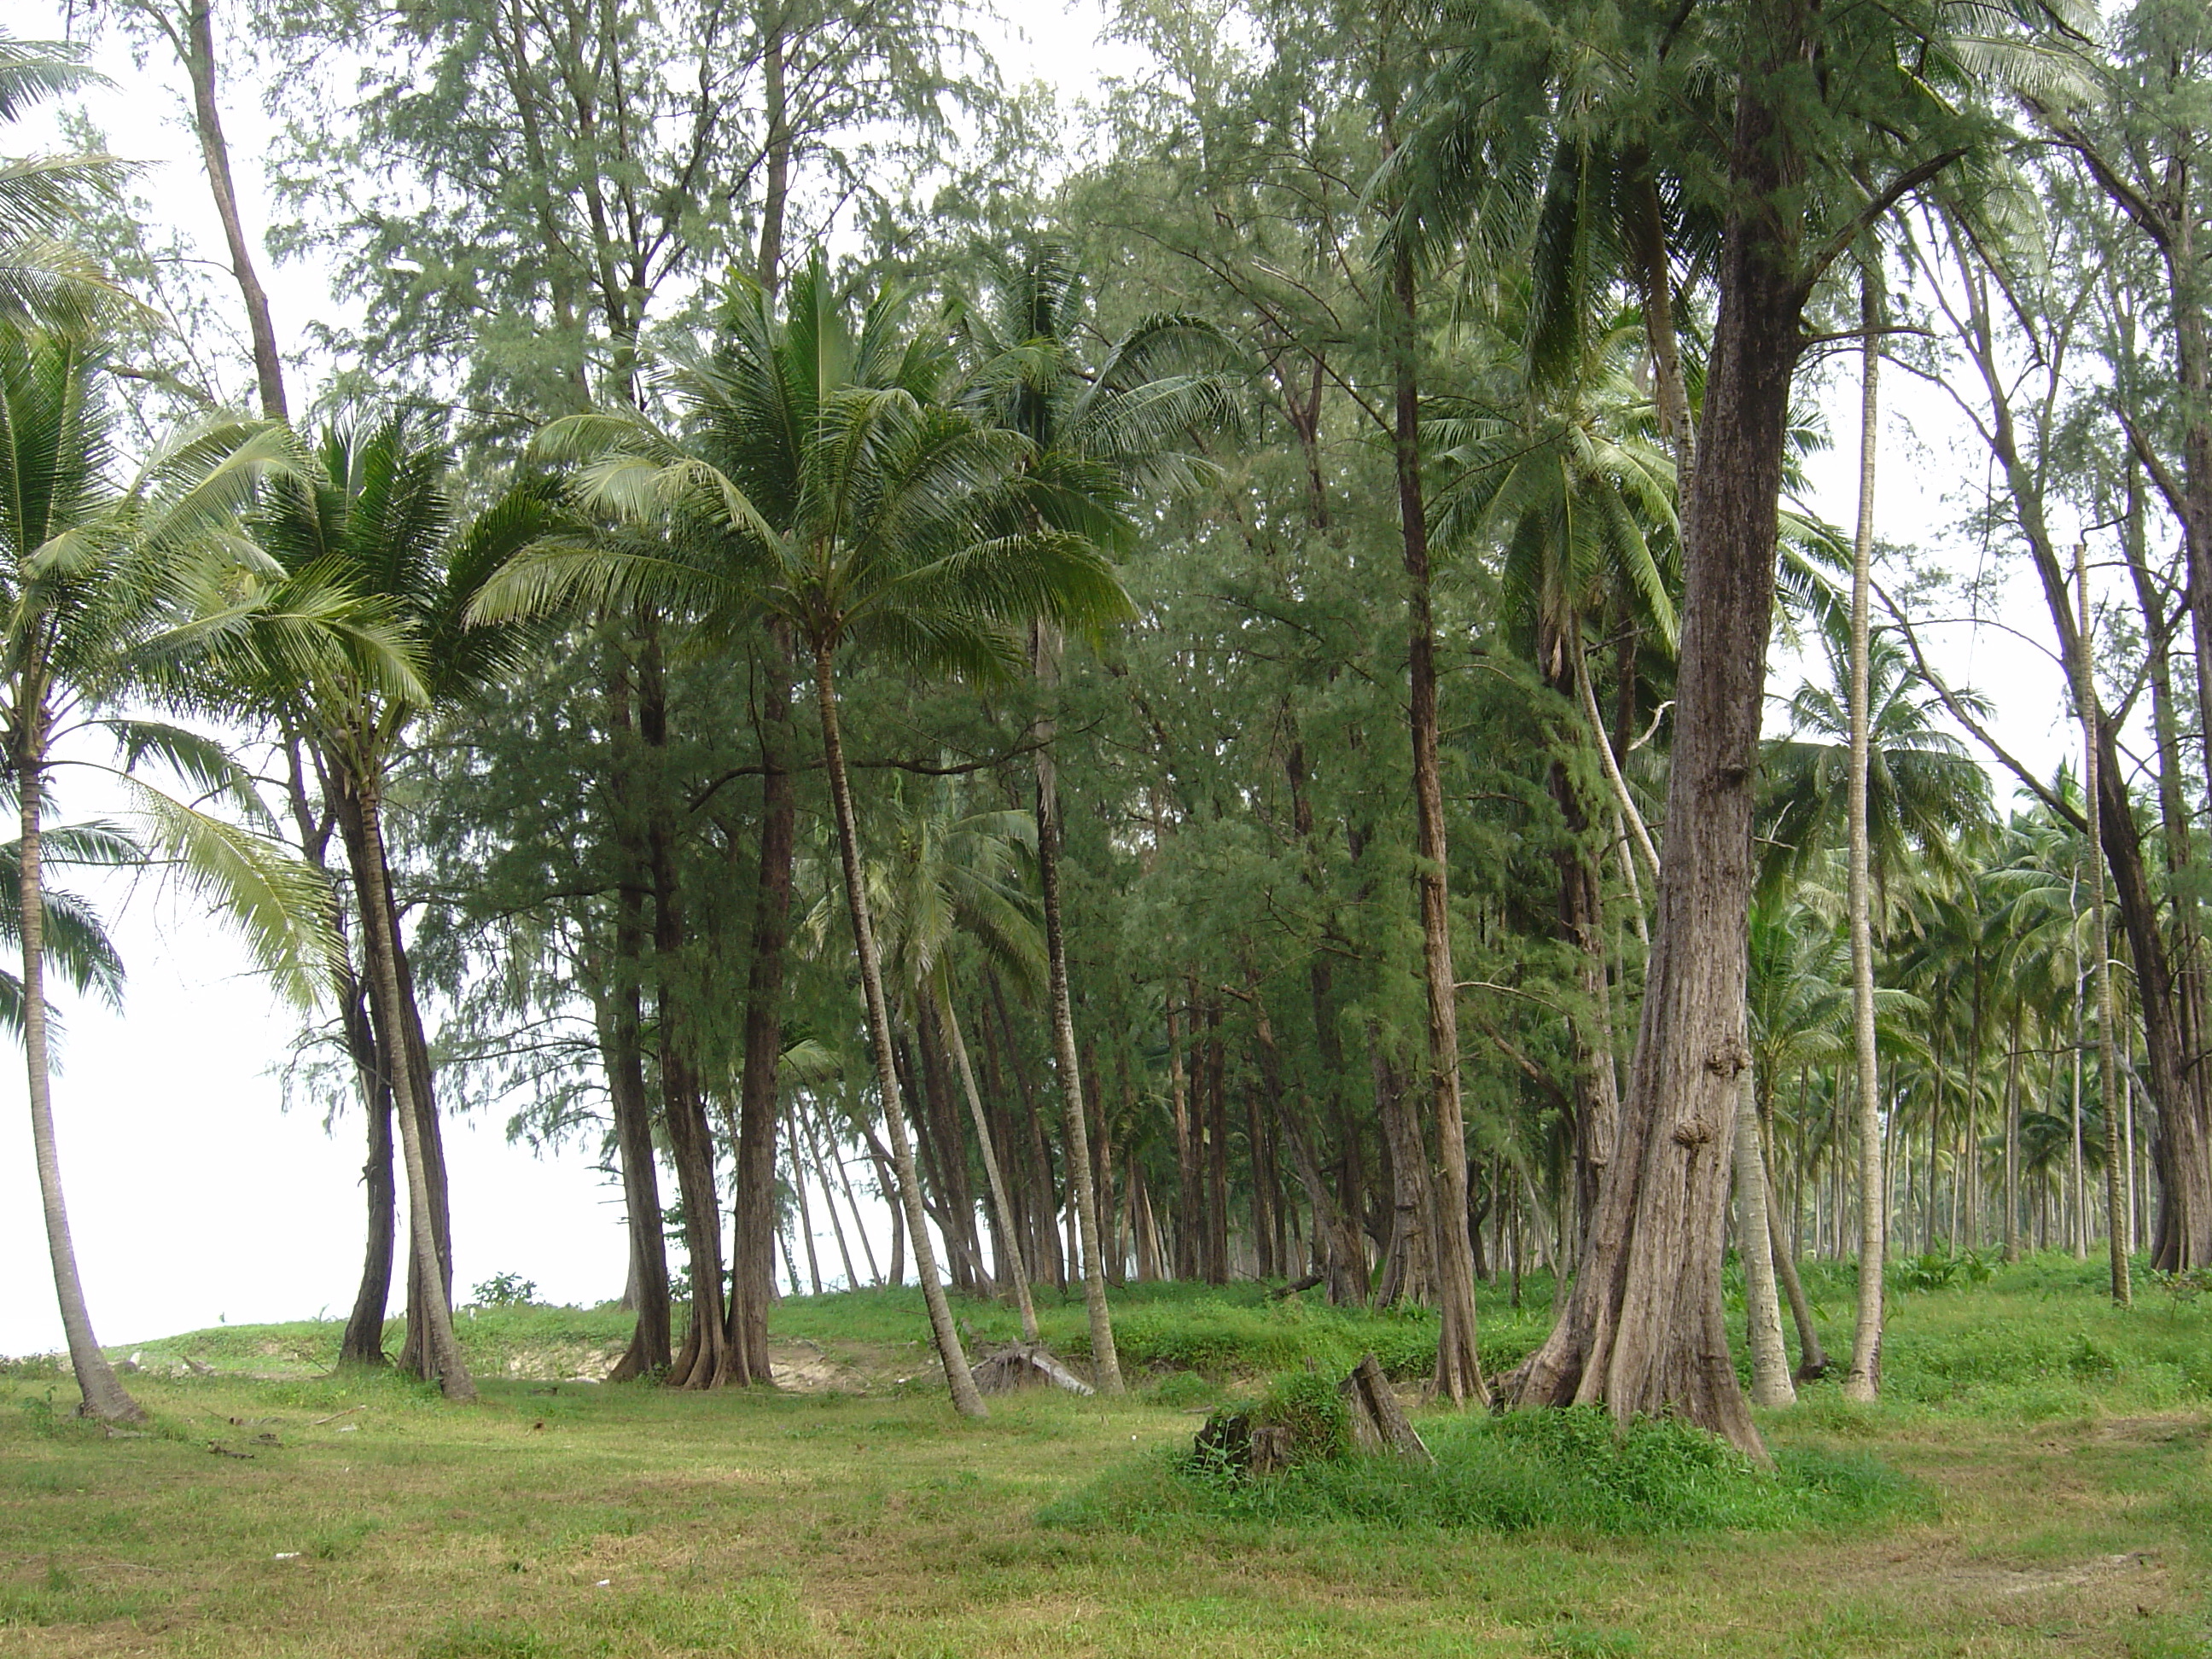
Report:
1516,45,1807,1460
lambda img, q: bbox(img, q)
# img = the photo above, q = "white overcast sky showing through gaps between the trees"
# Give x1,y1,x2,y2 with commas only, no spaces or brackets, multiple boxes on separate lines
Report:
0,0,2070,1353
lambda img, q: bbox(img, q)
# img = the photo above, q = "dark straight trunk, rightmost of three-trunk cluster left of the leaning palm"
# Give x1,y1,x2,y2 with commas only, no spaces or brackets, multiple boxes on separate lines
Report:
719,624,791,1385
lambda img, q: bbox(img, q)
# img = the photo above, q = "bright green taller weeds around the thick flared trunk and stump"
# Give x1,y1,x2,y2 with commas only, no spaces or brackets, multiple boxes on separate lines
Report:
1038,1409,1931,1537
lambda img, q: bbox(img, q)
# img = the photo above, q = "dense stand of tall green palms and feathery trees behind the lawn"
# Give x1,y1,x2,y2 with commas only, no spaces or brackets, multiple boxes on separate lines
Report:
0,0,2212,1440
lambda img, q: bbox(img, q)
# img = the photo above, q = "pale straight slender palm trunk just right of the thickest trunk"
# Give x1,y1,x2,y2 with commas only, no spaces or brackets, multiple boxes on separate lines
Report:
1842,274,1889,1400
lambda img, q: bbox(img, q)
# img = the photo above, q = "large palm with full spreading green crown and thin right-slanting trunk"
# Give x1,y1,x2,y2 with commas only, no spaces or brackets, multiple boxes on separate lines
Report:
475,254,1128,1416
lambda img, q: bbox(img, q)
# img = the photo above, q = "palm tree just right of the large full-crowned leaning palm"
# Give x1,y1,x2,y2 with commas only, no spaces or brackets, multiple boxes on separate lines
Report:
958,239,1234,1394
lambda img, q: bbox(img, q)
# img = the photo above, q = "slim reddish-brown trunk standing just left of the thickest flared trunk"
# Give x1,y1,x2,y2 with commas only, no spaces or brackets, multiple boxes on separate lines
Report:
1391,250,1491,1405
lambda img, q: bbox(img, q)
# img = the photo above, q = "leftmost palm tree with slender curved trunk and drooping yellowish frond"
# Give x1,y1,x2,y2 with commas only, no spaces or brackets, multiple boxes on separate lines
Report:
0,325,387,1420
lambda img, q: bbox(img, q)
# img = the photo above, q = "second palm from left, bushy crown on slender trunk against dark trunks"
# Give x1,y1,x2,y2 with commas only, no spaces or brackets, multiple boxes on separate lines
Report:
252,411,546,1400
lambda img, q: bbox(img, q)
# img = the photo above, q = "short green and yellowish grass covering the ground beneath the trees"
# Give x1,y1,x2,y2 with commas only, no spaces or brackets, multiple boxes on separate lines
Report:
0,1259,2212,1659
